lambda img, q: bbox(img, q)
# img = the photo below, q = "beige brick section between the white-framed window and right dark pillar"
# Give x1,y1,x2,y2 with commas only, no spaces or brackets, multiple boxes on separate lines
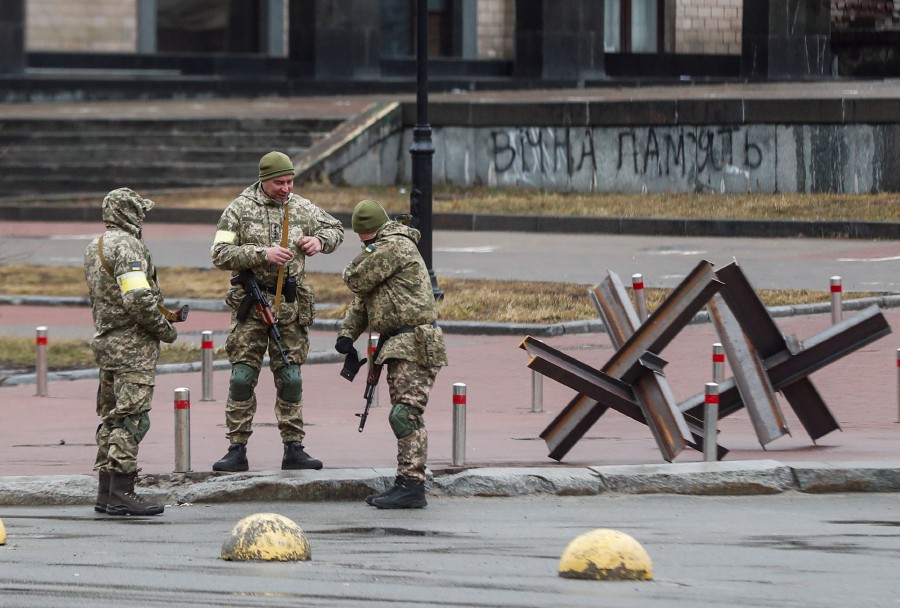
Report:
675,0,744,55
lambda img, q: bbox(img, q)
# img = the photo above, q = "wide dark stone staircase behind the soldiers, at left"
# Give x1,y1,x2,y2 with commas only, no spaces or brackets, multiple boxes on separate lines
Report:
0,118,342,200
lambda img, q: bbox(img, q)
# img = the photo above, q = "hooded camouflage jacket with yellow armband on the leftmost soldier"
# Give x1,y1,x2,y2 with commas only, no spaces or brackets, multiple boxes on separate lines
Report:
84,188,177,371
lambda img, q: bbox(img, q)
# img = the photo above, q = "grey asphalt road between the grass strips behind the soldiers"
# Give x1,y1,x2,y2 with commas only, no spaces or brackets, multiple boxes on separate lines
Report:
0,216,900,293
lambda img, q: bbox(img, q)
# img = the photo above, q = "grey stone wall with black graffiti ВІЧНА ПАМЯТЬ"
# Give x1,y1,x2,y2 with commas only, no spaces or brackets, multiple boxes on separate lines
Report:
324,100,900,193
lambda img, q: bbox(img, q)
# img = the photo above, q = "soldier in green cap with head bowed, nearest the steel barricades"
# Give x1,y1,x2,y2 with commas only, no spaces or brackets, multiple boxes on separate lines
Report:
335,200,447,509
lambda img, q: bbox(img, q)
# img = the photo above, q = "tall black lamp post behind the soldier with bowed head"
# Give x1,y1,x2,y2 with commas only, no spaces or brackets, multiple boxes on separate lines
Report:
409,0,444,300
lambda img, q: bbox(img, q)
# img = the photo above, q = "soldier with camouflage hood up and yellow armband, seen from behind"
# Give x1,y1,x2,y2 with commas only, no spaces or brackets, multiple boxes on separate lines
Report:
84,188,178,515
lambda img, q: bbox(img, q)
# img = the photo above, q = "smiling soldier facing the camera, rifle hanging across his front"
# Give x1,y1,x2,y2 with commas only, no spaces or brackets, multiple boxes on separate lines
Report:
212,152,344,471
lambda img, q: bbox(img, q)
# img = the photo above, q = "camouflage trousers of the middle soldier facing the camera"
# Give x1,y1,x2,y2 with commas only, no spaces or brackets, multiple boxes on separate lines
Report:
225,314,309,444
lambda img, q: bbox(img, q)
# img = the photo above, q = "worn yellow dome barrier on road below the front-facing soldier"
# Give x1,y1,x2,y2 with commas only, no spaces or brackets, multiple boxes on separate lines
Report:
222,513,312,562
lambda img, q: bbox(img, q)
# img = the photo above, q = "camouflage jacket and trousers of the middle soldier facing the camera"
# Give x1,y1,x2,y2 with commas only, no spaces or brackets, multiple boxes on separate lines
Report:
212,182,344,445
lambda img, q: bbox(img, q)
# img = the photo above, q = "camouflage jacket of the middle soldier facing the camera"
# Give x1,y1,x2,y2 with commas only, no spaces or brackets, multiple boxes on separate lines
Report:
211,182,344,316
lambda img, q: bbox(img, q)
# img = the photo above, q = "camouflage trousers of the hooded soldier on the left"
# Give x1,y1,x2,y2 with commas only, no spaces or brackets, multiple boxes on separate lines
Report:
94,369,155,473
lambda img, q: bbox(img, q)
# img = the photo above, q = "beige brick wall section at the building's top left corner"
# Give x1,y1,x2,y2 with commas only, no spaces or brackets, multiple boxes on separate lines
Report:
25,0,137,53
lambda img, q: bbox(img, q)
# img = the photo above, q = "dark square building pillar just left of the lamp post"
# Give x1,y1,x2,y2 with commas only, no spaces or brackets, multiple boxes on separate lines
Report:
288,0,381,80
